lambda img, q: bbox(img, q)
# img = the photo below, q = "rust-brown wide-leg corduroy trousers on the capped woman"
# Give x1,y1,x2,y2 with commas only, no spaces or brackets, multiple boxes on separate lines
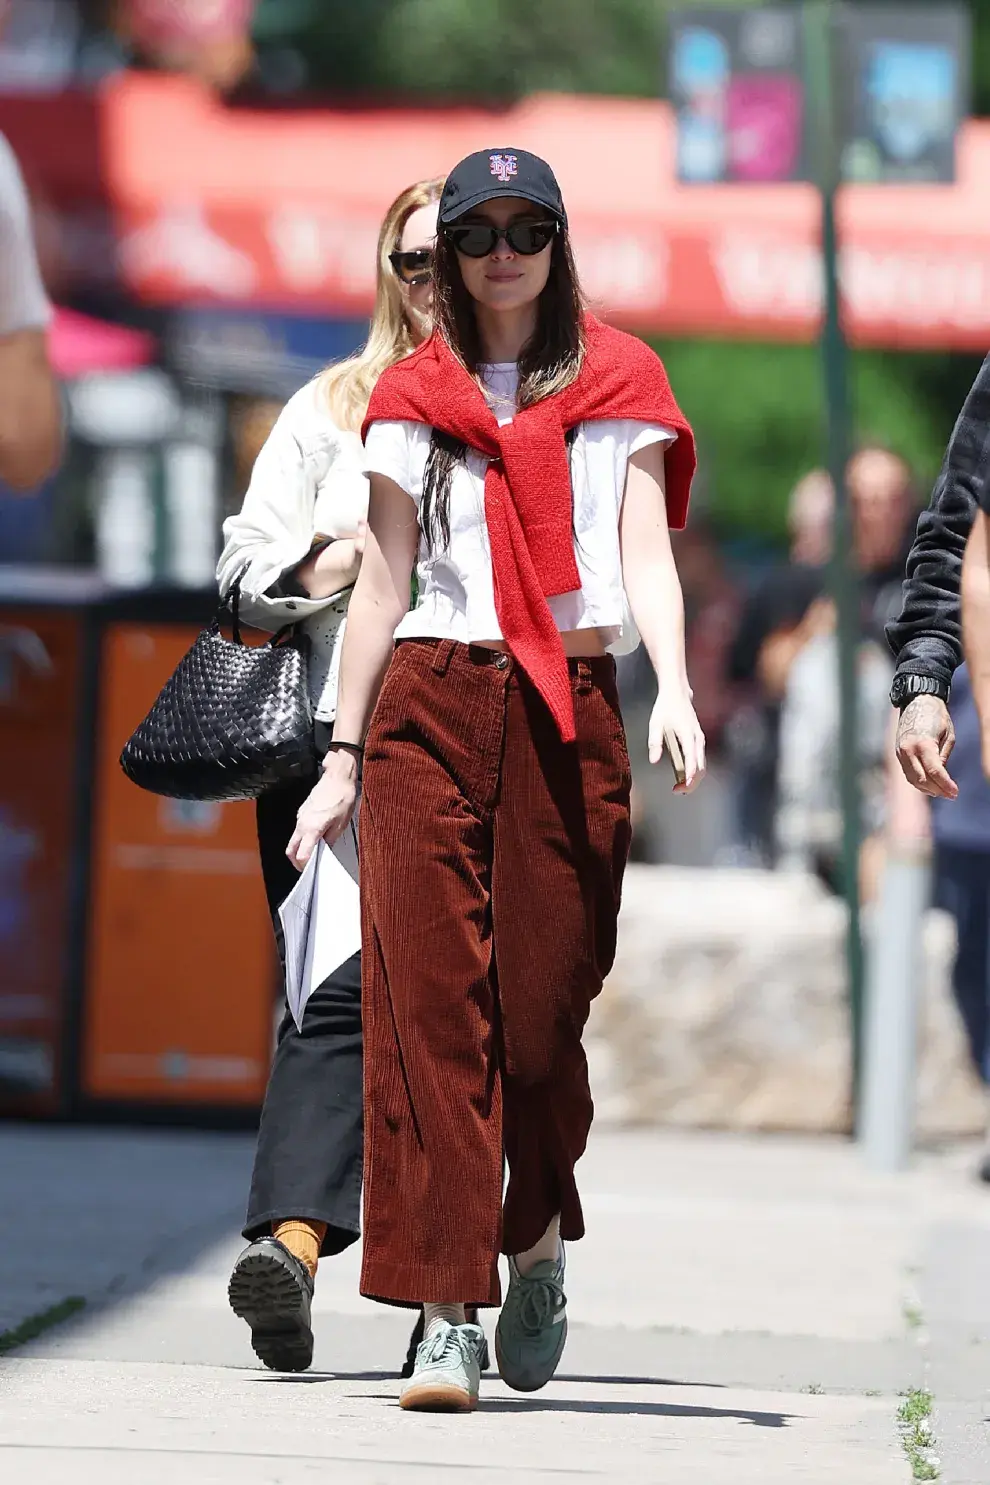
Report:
361,640,629,1305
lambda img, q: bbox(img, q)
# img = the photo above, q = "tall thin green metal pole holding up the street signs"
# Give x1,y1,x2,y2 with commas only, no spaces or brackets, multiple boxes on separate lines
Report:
804,0,864,1100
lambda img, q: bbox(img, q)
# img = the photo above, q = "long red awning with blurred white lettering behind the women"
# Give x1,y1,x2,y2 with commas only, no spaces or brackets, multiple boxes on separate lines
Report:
7,73,990,349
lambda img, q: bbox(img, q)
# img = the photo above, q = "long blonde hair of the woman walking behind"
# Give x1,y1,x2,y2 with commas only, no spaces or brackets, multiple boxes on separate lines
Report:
319,178,444,432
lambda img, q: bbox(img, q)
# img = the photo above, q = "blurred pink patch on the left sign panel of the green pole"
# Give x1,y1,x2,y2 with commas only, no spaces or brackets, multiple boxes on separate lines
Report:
726,73,801,181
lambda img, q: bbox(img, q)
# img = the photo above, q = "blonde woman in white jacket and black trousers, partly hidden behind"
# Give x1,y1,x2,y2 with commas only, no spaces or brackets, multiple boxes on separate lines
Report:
217,181,442,1371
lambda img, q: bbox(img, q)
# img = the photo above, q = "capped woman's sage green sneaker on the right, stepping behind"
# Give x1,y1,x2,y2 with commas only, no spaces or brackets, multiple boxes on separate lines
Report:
496,1250,567,1391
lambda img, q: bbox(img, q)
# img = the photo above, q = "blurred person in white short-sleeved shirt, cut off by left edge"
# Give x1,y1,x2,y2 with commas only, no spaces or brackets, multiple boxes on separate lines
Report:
0,134,62,492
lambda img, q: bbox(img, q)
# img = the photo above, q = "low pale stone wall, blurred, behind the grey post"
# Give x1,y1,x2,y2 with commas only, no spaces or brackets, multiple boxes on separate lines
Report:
588,866,986,1136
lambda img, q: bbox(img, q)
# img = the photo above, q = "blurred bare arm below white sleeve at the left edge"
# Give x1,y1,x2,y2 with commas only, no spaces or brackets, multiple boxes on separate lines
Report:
0,330,62,490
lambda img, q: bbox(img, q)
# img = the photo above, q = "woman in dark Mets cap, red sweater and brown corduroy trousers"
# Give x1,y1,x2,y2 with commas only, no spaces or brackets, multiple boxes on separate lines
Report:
287,150,704,1411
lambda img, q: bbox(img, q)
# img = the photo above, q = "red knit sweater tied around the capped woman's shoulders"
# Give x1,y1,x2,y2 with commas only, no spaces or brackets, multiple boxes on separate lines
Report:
362,315,696,743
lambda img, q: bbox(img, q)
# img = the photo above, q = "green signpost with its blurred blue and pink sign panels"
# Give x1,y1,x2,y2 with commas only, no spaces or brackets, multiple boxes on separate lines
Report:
669,0,969,1116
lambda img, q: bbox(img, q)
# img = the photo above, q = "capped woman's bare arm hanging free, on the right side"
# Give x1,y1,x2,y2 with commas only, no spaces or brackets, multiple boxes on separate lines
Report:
619,444,705,793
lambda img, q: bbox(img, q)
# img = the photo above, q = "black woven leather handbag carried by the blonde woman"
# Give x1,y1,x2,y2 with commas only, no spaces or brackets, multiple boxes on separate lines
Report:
120,587,316,799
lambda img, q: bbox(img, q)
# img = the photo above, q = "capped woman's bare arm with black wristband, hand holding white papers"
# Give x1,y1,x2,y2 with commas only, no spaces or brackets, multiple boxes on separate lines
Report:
286,474,419,869
